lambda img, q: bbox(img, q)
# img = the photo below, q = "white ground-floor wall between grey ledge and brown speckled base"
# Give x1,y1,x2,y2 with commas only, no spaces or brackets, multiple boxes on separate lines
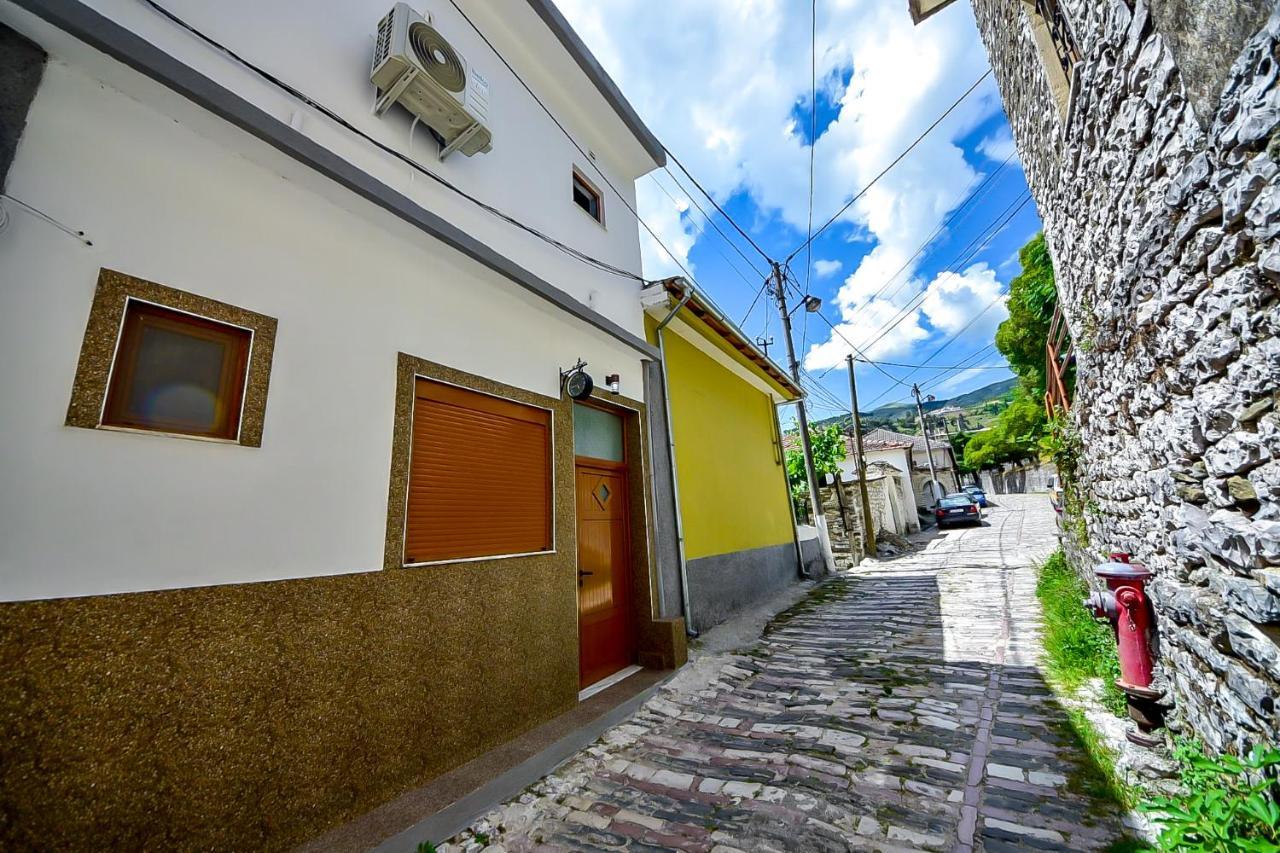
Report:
0,58,643,601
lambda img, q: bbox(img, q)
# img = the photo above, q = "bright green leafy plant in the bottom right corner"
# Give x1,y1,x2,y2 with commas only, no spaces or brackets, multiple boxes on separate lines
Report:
1139,740,1280,853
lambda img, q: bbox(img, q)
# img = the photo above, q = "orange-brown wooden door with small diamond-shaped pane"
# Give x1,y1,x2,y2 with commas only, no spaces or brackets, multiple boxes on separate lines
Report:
576,459,635,686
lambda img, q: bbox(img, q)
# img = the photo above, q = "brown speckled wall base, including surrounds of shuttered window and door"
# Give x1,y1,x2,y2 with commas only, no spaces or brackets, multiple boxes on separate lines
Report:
0,356,684,850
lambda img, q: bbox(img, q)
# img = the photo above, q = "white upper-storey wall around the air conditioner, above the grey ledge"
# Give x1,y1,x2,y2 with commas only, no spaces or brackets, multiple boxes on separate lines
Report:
0,0,654,337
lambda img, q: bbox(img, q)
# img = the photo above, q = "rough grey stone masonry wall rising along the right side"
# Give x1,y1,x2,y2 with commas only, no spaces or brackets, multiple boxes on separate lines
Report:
973,0,1280,749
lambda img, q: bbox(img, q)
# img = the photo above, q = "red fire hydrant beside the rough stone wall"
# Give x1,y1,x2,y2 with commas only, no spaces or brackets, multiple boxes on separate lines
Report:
1084,552,1164,745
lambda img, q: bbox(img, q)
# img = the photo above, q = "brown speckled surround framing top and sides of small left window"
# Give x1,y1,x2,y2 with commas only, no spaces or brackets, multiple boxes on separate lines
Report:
67,269,275,447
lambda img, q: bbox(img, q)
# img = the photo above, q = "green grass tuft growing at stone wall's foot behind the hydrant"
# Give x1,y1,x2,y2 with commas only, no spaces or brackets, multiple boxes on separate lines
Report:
1036,551,1125,717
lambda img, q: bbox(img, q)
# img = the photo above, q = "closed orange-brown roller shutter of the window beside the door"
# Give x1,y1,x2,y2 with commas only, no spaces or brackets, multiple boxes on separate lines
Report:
403,378,553,565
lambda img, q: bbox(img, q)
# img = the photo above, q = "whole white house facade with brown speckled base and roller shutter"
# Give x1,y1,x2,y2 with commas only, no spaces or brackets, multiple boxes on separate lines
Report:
0,0,684,847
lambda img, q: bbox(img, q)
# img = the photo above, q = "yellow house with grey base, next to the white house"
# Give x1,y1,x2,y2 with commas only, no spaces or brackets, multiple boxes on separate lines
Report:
643,278,803,630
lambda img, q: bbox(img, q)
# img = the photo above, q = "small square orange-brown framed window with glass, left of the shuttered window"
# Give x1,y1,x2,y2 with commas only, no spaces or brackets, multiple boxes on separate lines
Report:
102,298,253,441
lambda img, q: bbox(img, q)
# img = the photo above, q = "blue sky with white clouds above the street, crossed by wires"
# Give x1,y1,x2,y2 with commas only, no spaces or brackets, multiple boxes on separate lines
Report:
558,0,1039,418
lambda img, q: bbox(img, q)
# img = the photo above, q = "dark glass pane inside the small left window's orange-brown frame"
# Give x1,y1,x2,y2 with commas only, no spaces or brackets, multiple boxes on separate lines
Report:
125,324,227,429
